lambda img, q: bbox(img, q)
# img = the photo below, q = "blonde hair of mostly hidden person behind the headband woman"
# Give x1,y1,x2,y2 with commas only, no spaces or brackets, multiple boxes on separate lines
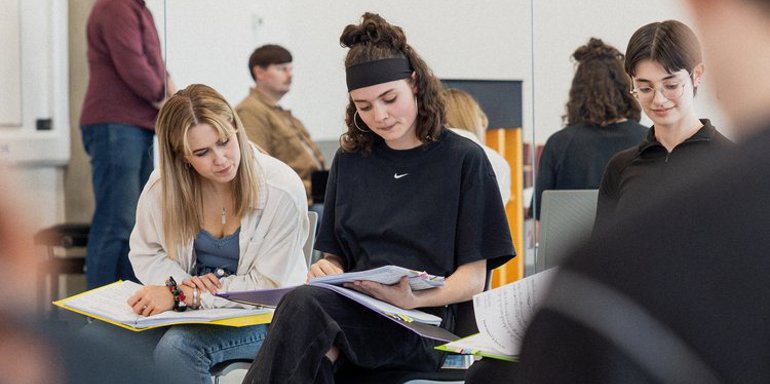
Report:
442,88,489,143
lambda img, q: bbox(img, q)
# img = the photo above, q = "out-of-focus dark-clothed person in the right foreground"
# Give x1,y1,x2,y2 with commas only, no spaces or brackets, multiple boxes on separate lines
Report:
520,9,770,384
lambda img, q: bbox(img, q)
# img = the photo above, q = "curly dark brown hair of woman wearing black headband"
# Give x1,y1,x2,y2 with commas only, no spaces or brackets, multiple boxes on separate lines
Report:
340,12,446,152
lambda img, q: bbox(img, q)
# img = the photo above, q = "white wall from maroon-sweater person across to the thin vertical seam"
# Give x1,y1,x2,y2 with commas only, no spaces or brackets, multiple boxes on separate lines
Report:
148,0,531,140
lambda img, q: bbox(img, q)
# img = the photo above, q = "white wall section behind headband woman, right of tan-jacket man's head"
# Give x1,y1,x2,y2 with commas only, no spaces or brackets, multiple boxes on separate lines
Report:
289,0,531,139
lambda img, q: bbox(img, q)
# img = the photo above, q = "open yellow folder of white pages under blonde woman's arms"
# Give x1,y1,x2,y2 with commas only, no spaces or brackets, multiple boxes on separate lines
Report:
53,281,273,332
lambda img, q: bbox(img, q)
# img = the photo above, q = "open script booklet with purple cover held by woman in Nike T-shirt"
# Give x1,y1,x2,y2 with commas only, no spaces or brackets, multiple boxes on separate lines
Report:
217,265,458,342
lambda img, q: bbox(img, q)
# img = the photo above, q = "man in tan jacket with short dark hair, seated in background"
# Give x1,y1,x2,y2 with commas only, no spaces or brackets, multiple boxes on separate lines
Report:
235,44,324,205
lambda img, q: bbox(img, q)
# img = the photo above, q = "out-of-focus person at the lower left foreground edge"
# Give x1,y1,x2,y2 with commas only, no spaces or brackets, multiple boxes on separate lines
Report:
0,165,166,384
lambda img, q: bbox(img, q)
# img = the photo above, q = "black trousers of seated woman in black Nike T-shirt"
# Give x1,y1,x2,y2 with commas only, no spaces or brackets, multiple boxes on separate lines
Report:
243,286,446,384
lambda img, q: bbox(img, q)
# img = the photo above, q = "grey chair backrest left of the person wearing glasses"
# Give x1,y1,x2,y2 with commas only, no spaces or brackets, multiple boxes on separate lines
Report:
534,189,598,273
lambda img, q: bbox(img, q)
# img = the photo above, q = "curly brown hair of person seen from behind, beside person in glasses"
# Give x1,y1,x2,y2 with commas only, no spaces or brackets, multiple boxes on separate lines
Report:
562,37,642,125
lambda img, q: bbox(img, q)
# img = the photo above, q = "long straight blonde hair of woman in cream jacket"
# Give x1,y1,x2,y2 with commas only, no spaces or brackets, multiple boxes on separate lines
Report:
155,84,258,259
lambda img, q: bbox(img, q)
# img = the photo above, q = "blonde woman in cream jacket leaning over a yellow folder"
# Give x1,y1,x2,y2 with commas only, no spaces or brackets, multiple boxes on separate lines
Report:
79,85,308,384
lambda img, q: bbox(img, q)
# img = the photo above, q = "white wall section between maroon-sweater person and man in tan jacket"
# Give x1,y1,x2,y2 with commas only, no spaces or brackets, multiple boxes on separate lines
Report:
147,0,289,104
